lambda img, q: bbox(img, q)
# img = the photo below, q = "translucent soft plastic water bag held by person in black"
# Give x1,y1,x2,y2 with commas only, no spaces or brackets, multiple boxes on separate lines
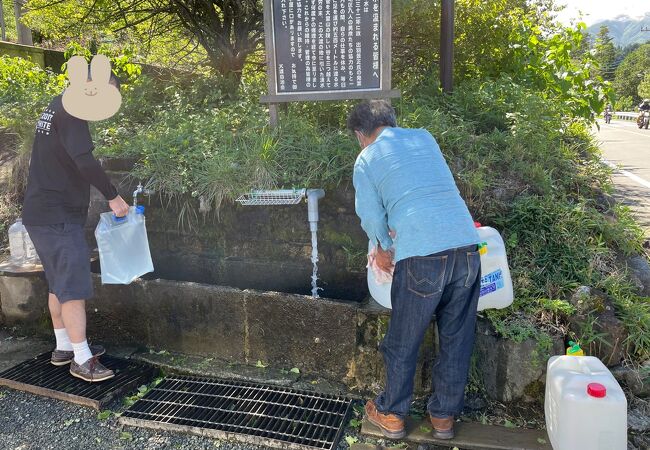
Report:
95,206,153,284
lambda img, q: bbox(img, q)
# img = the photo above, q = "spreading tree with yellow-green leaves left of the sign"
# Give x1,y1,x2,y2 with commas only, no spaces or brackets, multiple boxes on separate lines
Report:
24,0,264,81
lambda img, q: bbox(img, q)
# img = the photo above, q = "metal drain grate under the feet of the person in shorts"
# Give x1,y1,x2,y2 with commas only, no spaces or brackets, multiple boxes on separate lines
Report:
0,352,155,410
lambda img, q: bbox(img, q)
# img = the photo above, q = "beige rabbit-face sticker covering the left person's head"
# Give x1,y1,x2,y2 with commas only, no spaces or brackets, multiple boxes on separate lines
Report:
62,55,122,121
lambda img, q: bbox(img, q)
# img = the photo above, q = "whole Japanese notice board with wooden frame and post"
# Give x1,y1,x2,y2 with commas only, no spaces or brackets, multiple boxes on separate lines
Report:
261,0,400,126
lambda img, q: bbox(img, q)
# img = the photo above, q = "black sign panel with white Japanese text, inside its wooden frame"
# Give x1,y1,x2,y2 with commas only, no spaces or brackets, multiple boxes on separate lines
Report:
272,0,382,94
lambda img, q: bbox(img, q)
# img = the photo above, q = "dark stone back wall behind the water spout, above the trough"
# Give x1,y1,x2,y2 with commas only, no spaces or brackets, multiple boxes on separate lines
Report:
88,161,368,301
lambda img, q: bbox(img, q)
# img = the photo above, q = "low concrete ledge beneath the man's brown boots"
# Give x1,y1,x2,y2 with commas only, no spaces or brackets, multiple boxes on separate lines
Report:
361,418,548,450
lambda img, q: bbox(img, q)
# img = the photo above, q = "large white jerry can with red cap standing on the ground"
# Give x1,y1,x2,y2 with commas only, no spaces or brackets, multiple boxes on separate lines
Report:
544,355,627,450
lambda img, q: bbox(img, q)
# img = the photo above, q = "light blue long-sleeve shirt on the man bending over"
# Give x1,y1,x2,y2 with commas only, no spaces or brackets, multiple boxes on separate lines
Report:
353,127,479,262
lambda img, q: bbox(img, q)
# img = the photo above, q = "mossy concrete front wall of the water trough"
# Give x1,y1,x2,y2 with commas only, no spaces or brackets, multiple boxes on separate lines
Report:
0,272,435,391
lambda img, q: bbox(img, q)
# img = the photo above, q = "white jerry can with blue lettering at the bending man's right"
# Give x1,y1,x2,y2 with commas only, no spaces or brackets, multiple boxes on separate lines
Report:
476,223,515,311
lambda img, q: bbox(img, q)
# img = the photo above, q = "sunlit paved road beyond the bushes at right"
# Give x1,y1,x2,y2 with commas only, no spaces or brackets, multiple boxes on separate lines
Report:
596,120,650,238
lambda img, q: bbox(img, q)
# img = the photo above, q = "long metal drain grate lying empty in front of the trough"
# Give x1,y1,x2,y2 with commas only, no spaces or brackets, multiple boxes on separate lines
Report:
120,377,352,450
